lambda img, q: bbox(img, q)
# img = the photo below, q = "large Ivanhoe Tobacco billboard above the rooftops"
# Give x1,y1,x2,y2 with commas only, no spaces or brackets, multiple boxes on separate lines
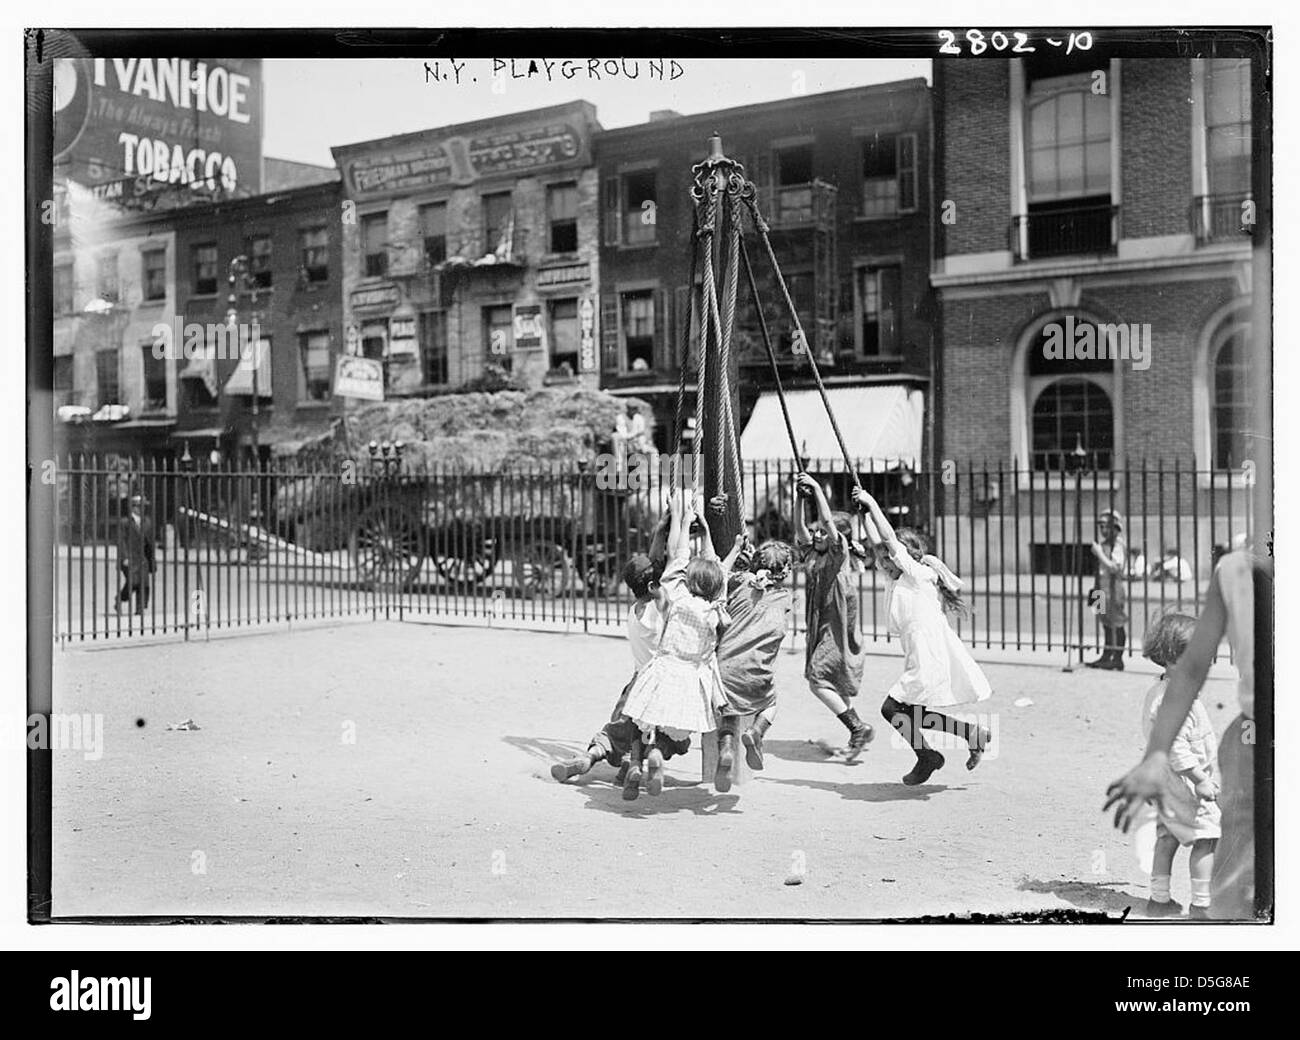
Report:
53,57,263,209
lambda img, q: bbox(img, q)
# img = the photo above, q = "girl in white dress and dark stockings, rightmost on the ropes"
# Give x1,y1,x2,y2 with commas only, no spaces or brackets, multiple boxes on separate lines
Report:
853,488,992,787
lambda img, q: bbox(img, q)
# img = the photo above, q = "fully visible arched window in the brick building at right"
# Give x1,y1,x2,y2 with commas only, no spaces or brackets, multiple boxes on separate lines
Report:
1024,317,1115,472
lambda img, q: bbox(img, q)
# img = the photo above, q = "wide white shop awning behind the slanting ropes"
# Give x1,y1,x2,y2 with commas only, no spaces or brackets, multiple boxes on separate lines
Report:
740,384,924,471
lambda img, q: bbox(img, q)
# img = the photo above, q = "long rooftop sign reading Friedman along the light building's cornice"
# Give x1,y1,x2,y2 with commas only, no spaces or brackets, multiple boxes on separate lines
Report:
339,122,586,199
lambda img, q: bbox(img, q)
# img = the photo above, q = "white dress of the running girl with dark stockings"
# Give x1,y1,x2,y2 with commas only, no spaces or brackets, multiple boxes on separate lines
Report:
885,551,992,707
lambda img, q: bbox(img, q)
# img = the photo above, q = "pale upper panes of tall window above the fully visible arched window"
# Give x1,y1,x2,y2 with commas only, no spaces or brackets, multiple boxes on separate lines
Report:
1026,73,1110,203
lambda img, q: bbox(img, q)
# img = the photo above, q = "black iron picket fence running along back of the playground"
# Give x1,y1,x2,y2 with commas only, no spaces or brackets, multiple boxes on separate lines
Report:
53,456,1252,655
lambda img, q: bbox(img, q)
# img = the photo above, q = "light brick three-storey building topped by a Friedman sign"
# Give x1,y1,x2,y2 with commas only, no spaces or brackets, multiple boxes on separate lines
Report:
333,101,601,398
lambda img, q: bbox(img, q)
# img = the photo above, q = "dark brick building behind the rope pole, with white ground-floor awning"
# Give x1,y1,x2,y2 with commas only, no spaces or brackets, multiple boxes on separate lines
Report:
595,79,933,465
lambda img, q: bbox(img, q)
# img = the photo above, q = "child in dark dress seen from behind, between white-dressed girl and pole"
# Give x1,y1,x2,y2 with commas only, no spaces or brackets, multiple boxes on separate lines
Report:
714,541,794,792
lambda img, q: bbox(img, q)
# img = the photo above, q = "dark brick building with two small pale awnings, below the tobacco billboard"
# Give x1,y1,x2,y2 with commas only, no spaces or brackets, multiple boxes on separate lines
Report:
172,179,343,456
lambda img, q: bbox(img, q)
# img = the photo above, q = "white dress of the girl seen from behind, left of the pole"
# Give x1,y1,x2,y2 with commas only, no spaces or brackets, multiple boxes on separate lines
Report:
623,559,727,740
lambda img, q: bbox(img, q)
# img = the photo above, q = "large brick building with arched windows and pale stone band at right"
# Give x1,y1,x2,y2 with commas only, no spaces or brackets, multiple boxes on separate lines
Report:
932,53,1255,569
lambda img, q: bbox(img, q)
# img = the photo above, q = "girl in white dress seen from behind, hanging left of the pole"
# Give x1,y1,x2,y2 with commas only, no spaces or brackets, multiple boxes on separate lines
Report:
623,495,729,796
